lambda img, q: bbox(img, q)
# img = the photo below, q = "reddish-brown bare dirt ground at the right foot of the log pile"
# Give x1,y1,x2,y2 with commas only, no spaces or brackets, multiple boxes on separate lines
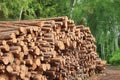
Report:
90,66,120,80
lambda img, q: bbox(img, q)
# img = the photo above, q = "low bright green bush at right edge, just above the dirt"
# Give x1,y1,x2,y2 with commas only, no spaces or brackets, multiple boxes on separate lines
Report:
110,50,120,66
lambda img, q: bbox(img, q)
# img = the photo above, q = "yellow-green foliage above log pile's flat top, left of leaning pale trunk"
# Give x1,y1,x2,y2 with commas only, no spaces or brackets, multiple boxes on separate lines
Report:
0,0,71,20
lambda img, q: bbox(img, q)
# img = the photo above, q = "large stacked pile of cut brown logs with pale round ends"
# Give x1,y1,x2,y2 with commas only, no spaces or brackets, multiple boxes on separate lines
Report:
0,16,105,80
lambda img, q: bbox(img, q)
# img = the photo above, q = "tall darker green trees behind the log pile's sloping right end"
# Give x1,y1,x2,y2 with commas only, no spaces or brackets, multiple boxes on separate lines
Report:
73,0,120,61
